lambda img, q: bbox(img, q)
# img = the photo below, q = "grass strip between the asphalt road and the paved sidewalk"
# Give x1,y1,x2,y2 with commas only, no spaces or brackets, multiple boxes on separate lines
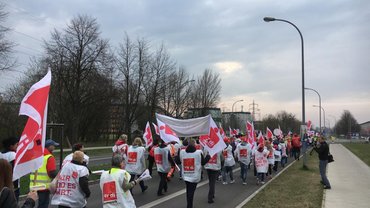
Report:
244,154,323,208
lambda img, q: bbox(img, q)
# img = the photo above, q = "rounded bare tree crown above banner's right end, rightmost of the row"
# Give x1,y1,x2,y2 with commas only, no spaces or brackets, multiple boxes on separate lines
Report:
191,69,221,108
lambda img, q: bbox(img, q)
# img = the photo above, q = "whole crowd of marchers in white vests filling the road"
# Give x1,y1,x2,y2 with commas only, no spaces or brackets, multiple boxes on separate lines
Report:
0,129,330,208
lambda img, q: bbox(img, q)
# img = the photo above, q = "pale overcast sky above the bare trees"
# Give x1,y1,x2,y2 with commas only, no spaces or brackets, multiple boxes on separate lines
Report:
0,0,370,128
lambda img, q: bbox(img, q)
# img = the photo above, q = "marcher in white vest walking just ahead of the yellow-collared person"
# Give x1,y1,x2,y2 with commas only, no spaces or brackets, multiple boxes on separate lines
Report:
126,137,148,193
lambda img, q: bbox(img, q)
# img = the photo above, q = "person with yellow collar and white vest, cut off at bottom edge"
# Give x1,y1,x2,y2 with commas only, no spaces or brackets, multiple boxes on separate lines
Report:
99,154,140,208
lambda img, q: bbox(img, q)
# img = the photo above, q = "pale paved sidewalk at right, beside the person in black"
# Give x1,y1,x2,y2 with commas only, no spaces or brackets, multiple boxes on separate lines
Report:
323,144,370,208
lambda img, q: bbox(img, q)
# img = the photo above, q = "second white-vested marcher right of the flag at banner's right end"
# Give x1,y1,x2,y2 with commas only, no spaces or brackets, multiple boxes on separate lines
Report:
235,137,252,185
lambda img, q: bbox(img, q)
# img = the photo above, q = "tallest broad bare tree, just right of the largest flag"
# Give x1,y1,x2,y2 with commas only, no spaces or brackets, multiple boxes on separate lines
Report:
45,15,111,145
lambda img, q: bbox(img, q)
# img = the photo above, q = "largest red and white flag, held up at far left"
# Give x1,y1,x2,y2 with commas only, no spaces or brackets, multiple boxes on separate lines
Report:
13,71,51,180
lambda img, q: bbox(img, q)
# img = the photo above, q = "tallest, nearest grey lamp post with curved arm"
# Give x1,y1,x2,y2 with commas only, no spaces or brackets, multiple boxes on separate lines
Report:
263,17,307,168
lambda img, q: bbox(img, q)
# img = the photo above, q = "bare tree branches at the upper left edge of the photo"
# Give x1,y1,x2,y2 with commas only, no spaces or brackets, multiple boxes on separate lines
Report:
0,3,15,72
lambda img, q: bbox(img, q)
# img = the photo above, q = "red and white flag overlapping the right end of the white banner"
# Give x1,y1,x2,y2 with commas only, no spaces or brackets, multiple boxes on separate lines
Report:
199,118,226,157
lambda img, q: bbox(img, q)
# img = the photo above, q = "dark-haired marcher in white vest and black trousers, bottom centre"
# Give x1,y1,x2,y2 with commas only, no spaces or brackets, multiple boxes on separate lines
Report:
177,139,210,208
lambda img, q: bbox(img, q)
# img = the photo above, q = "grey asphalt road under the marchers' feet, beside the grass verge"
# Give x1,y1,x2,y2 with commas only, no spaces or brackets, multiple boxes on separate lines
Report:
51,158,293,208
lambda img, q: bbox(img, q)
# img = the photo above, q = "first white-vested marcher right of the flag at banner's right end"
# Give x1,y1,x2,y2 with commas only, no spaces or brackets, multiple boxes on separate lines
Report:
222,138,235,185
